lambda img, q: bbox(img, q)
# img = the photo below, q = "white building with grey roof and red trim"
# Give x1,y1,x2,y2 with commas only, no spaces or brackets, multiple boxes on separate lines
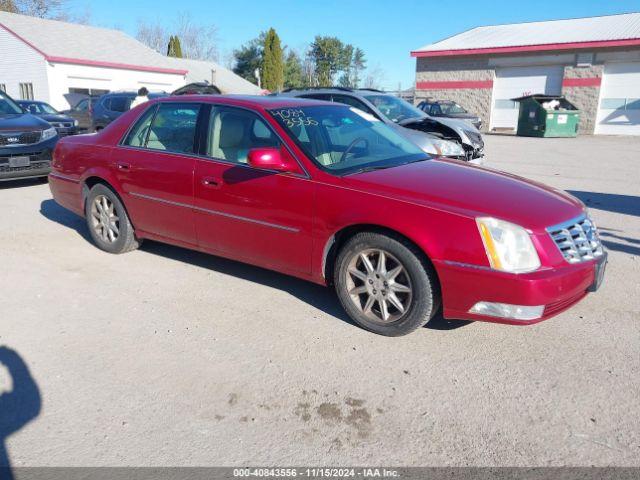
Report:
0,12,261,110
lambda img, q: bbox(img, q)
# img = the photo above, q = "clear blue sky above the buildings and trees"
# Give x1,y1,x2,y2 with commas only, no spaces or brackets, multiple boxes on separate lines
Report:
67,0,640,90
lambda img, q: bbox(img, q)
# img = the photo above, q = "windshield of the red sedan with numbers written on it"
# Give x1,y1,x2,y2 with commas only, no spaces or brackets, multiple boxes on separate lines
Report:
270,105,429,175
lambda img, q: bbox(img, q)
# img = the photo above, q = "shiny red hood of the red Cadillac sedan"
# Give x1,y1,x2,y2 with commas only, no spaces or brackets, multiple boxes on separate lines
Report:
342,159,584,232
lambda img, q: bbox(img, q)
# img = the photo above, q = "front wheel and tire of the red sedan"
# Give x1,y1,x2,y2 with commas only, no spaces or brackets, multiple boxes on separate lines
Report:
334,232,440,337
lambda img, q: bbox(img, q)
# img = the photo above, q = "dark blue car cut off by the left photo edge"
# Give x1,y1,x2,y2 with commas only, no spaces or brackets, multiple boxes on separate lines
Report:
0,91,58,180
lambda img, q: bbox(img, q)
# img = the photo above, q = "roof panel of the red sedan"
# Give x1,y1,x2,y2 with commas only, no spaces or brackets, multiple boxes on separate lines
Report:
153,95,336,110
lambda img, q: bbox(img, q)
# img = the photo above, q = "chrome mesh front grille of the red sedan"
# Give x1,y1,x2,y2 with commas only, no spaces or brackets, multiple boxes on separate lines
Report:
547,215,604,263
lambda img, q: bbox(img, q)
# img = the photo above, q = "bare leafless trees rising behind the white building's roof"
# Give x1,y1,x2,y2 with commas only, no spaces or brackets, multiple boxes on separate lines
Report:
136,13,218,60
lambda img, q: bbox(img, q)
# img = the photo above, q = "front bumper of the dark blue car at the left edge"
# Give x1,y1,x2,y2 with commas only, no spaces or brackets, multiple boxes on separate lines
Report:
0,137,58,181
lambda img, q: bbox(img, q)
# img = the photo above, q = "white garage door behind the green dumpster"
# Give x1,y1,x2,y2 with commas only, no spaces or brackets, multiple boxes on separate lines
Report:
490,66,564,129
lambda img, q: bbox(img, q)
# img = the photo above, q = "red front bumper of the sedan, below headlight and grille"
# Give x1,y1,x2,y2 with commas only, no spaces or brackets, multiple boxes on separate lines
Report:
434,256,606,325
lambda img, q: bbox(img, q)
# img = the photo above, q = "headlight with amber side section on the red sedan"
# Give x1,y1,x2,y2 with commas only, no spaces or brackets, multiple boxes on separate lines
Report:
476,217,540,273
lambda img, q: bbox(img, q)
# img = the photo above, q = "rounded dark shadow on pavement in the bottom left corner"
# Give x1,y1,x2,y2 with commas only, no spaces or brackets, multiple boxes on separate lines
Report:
0,345,42,480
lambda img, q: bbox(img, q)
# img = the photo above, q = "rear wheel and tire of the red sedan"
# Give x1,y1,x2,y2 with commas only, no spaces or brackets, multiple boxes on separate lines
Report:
84,183,141,254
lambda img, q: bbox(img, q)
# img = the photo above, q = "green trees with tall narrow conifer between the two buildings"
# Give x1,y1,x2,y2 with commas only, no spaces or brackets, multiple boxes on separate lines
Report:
233,28,372,92
